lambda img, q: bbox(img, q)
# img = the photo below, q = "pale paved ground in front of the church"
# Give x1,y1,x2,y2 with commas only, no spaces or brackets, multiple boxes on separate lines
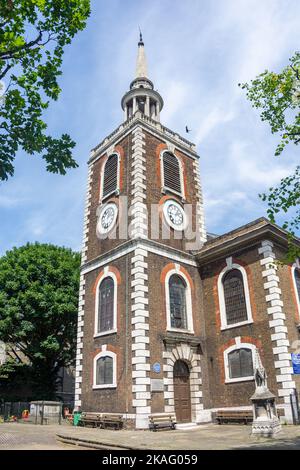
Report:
0,423,300,450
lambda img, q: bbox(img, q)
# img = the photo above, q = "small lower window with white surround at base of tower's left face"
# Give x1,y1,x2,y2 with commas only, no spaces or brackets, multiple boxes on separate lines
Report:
93,351,117,388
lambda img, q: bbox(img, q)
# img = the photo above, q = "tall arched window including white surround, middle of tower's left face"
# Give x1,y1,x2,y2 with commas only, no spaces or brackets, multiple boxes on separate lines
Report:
95,272,117,336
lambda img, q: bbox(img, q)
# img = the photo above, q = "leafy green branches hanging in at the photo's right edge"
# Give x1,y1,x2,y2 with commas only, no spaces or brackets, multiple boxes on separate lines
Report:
240,52,300,261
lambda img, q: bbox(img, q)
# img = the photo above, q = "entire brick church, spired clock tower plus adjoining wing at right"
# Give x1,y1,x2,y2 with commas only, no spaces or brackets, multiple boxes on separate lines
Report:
75,38,300,428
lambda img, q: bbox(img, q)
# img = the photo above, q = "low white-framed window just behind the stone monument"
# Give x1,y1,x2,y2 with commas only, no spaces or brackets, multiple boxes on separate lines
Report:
224,343,256,383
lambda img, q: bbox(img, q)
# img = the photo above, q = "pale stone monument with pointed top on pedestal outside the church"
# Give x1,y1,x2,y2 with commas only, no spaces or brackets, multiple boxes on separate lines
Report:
251,350,281,437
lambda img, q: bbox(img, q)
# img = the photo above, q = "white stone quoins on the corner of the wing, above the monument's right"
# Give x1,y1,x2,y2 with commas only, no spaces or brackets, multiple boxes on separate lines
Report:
258,240,295,420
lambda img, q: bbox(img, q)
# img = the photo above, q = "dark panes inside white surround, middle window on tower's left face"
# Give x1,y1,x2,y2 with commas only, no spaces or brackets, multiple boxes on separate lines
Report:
97,276,115,333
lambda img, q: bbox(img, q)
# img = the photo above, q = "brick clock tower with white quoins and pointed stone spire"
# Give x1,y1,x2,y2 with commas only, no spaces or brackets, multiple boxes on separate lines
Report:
75,35,206,428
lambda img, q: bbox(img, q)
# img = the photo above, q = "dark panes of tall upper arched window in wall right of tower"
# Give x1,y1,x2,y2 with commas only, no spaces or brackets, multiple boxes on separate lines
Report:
223,269,248,325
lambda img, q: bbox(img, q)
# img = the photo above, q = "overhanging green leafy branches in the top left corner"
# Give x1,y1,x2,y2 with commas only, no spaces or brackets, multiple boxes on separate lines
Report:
0,0,90,180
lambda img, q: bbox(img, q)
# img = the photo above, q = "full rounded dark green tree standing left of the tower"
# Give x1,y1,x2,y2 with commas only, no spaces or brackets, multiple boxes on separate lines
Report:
0,243,80,399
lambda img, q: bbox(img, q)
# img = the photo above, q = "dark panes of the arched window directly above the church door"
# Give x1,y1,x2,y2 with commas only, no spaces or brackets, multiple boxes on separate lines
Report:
169,274,187,329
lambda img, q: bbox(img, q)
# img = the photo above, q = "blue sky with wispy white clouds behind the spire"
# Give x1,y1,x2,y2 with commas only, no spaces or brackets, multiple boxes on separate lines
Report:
0,0,300,254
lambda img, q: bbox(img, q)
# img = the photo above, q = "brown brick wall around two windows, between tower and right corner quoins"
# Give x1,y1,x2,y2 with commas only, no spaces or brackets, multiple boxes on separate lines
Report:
200,245,277,408
